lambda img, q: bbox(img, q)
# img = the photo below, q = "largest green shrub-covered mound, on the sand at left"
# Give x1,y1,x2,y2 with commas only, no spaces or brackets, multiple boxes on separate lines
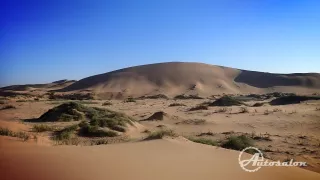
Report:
38,102,134,139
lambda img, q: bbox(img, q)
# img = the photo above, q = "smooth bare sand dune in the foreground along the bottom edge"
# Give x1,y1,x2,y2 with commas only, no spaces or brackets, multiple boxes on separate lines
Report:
0,137,320,180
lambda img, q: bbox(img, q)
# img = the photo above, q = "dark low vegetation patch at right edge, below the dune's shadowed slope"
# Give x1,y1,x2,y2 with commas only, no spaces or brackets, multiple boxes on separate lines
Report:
270,95,320,105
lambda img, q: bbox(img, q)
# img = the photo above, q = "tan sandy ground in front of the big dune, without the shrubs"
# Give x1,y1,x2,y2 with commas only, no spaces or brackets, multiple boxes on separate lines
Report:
0,99,320,179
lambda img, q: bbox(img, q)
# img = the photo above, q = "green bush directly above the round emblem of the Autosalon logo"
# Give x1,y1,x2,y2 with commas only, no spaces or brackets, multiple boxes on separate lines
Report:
221,135,253,151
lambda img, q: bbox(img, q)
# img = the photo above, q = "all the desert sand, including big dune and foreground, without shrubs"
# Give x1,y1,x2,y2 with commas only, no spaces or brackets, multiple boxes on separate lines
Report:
0,63,320,180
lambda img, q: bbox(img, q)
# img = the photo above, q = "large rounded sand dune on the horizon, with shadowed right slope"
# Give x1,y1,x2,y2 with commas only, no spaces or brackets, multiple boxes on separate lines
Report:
62,62,320,97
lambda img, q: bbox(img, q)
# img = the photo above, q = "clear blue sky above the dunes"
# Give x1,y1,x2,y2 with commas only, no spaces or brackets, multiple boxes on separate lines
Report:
0,0,320,86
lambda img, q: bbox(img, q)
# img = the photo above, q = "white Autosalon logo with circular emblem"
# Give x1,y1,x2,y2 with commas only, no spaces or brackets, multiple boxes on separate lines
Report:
238,147,307,172
